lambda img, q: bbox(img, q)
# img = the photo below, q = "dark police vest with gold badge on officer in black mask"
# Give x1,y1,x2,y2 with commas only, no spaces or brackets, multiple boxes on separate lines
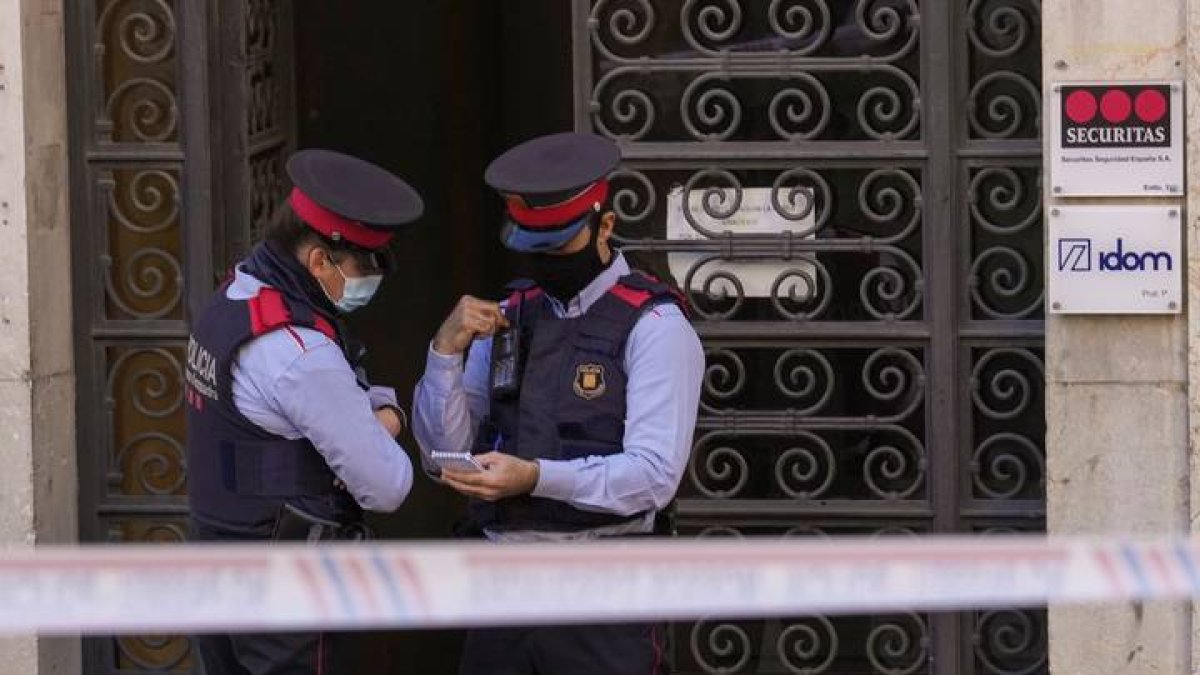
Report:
472,273,682,531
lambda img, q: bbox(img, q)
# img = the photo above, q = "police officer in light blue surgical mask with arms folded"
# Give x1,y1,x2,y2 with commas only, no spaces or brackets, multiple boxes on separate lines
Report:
186,150,422,675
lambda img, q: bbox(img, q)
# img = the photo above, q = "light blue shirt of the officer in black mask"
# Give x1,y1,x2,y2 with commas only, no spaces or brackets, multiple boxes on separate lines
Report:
413,253,704,540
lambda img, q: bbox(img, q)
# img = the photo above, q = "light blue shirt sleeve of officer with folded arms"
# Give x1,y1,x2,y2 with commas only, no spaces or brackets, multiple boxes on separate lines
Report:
269,344,413,512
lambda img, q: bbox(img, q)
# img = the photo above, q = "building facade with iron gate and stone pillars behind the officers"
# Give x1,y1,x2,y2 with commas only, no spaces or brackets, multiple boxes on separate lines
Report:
0,0,1200,675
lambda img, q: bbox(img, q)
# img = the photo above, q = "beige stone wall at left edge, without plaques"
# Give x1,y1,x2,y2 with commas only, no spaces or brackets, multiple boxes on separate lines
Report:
0,0,80,675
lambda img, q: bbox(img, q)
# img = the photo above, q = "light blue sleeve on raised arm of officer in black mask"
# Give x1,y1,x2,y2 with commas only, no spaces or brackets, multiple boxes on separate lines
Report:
413,338,492,476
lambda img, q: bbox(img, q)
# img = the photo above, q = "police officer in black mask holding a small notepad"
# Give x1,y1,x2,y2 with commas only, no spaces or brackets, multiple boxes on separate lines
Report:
413,133,704,675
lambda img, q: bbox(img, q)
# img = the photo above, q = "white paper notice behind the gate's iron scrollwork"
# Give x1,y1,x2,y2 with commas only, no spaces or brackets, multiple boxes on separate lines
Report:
667,187,818,300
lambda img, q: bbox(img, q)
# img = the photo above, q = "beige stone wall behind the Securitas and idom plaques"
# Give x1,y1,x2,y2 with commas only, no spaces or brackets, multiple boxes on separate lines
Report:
1043,0,1200,675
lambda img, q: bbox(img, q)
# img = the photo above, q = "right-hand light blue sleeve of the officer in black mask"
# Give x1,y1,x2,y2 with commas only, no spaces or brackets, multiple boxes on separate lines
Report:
533,306,704,515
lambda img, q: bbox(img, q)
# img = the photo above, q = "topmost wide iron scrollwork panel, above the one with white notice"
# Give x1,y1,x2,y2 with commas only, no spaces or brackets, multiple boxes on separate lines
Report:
589,0,920,142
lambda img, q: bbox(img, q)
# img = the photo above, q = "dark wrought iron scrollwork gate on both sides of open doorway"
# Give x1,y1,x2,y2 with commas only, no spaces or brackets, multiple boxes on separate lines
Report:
66,0,1046,675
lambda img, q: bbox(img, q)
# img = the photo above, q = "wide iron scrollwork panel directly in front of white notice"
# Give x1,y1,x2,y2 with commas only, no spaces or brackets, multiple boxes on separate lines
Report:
612,165,924,321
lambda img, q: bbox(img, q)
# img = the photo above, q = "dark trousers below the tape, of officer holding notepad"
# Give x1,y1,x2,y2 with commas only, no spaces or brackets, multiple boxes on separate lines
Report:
458,623,666,675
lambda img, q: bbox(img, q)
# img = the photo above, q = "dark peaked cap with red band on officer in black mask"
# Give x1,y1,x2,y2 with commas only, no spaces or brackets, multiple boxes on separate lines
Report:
484,132,620,252
